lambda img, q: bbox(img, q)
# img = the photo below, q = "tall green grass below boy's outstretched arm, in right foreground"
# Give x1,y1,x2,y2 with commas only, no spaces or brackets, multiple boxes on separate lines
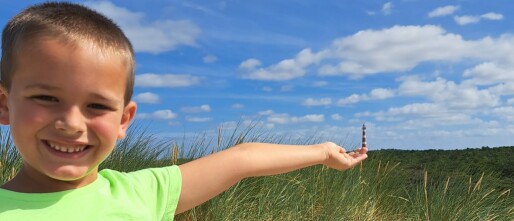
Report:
176,161,514,221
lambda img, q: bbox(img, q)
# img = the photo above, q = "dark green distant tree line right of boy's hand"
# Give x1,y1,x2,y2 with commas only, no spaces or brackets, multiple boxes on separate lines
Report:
369,146,514,189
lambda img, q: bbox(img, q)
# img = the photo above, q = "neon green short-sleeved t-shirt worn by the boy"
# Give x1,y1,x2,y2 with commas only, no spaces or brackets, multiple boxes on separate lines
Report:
0,166,182,221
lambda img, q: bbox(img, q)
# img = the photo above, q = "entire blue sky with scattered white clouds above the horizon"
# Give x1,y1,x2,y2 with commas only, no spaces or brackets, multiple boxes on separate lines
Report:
0,0,514,149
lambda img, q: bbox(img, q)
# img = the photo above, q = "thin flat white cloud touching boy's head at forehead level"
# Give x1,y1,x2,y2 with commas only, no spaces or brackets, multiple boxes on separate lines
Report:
135,73,202,88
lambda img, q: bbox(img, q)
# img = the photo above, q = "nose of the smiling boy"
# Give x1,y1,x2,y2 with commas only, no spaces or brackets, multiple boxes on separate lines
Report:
55,108,86,135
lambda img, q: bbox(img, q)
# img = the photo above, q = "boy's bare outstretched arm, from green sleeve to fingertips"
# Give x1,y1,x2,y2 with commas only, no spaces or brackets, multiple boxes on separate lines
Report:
177,142,368,213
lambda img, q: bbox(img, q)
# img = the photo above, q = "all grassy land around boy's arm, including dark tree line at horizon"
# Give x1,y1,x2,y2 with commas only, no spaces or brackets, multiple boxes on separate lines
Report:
0,127,514,221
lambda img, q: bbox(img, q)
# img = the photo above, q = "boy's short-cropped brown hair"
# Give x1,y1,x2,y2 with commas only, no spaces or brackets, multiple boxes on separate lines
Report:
0,2,134,105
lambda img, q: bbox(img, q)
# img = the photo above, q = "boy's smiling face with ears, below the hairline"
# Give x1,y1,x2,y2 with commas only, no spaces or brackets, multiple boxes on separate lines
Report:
0,38,136,186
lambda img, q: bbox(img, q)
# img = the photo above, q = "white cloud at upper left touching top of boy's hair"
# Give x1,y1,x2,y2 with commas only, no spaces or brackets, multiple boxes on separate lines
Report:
85,1,201,54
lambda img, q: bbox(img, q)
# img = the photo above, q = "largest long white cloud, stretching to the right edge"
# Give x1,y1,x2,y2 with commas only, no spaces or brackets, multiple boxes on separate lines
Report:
240,25,514,80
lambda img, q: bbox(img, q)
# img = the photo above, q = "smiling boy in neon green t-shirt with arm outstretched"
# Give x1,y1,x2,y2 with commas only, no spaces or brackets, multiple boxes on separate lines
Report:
0,3,367,220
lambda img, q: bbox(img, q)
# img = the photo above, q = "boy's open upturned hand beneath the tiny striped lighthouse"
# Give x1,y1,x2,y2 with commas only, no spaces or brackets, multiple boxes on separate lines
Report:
321,142,368,170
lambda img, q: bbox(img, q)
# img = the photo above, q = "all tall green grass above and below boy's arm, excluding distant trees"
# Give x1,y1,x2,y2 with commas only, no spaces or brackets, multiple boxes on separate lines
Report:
0,124,514,221
